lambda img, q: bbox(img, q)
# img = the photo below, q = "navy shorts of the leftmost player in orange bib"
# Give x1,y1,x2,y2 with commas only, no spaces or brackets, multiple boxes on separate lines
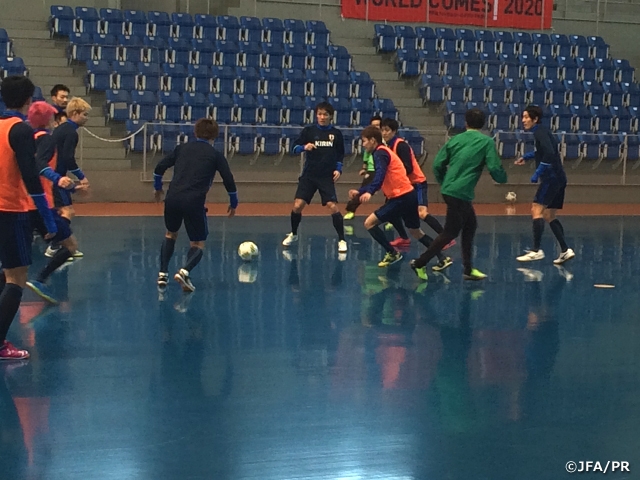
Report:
0,212,33,268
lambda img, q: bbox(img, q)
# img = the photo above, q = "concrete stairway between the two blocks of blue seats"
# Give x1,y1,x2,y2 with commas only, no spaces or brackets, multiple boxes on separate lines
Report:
229,0,447,158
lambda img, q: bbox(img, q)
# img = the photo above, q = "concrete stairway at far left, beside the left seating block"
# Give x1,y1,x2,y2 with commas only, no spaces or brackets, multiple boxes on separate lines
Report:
0,18,131,171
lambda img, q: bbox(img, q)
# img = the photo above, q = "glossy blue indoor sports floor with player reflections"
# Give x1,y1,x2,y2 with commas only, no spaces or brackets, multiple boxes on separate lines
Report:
0,217,640,480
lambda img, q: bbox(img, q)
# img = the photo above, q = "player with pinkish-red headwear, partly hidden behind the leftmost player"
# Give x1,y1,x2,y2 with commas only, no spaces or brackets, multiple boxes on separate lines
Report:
27,102,84,304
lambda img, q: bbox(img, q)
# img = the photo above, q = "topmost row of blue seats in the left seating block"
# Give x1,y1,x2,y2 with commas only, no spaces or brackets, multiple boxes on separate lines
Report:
50,5,330,45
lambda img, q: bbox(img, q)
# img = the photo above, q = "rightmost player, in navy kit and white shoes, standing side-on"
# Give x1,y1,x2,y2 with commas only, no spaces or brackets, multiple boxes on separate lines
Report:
515,105,576,265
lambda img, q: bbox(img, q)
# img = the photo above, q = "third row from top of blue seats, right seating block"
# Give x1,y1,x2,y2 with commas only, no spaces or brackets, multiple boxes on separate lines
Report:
420,74,640,107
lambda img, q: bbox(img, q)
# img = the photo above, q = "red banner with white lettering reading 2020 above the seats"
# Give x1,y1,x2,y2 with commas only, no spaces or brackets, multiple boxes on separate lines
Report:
342,0,553,30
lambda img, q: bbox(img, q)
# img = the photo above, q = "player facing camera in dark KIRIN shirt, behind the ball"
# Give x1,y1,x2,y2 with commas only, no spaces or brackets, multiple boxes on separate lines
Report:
282,102,347,253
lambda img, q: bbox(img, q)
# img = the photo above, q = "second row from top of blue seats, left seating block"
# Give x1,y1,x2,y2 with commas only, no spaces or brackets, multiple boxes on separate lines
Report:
67,34,351,72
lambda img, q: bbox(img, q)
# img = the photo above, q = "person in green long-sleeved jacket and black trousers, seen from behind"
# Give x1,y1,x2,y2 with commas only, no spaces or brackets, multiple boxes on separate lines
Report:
411,108,507,280
